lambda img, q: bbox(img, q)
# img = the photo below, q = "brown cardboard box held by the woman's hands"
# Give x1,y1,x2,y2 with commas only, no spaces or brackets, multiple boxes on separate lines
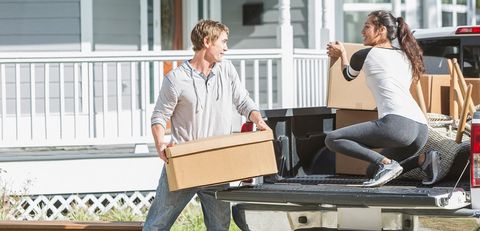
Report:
327,43,376,110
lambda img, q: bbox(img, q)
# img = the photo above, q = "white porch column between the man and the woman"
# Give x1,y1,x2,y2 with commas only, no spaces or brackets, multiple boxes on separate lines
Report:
277,0,296,108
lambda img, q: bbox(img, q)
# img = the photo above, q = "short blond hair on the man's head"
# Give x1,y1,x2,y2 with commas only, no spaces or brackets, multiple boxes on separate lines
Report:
190,19,229,51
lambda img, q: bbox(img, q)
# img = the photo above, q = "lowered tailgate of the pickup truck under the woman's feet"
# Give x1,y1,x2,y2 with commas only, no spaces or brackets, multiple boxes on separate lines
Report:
217,175,469,209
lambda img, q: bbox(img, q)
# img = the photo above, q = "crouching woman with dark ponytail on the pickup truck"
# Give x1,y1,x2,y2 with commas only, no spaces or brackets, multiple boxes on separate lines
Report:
325,11,439,187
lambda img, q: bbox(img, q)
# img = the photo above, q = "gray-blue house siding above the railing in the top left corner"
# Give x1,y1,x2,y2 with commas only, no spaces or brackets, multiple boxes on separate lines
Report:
0,0,80,52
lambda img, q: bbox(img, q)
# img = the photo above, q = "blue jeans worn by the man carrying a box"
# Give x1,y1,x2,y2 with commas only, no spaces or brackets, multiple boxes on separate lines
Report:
143,168,230,231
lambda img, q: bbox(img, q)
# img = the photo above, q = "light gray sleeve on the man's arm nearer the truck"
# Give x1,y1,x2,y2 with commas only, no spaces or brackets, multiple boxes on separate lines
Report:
228,62,259,119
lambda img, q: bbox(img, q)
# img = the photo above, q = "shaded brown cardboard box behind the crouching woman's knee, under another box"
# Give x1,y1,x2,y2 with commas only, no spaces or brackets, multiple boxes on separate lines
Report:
335,110,378,175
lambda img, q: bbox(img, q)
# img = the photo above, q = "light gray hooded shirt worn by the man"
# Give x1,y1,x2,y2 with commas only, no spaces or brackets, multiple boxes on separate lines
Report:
151,60,258,143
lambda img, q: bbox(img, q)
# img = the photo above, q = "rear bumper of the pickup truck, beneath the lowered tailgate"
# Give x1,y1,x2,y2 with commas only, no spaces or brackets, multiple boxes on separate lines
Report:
232,203,480,230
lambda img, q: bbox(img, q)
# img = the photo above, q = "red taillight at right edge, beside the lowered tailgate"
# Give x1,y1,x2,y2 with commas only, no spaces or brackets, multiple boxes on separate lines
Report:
470,112,480,187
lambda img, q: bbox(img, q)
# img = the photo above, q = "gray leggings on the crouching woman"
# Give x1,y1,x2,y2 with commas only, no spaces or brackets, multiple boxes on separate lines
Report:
325,114,428,172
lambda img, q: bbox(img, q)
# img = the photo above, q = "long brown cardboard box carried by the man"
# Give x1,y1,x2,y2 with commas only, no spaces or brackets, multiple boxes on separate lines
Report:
165,131,278,191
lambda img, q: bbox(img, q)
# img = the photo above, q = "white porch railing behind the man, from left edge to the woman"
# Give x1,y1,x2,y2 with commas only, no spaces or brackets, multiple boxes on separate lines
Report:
0,49,328,147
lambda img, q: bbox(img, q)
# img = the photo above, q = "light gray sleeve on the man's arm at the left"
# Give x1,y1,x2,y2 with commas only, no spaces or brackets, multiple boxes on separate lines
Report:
151,76,178,128
